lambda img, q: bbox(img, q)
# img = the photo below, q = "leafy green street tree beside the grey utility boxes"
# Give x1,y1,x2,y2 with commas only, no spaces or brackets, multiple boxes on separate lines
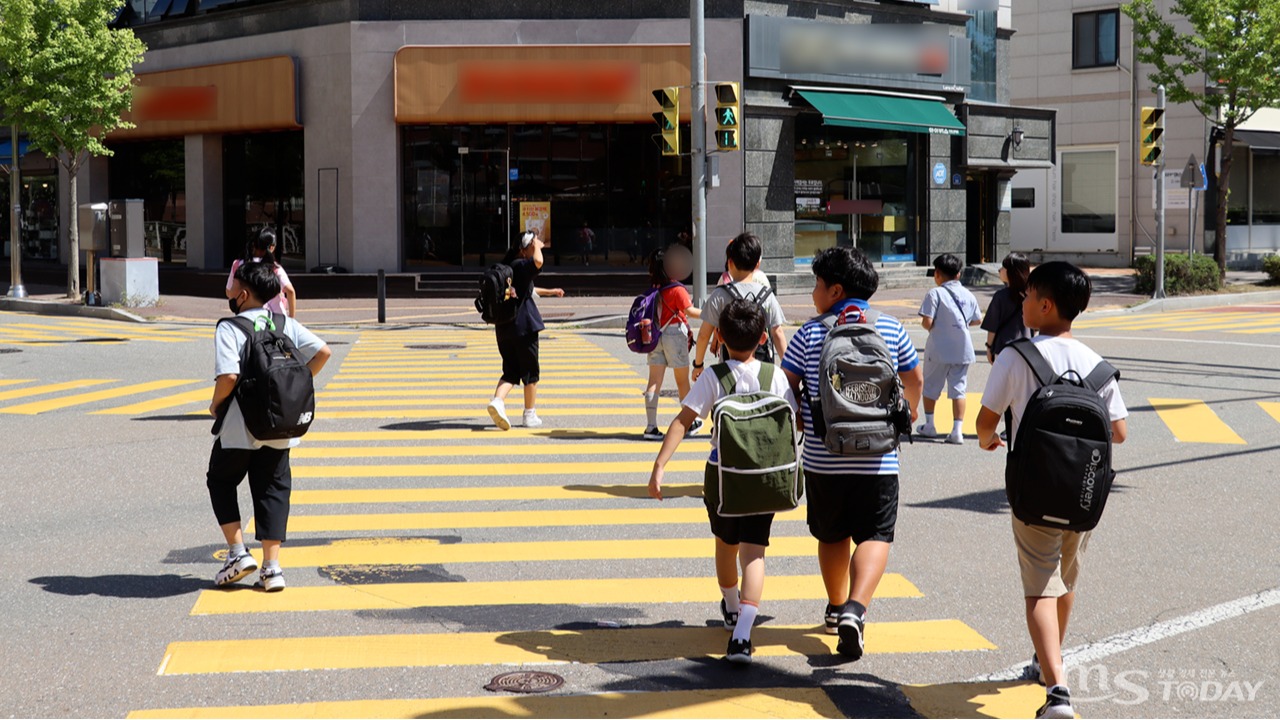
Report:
0,0,146,299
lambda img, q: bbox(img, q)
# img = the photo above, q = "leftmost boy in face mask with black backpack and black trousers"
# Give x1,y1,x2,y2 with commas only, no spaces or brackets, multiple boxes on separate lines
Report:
206,257,330,592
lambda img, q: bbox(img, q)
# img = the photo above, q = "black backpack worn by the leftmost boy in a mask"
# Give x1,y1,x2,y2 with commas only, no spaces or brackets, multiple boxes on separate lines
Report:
214,313,316,439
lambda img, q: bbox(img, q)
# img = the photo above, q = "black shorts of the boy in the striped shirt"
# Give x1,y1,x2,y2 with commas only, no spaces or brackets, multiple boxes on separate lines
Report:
804,470,897,543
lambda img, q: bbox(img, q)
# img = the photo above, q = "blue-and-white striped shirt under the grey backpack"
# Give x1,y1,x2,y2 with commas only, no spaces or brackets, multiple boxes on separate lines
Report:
782,300,920,475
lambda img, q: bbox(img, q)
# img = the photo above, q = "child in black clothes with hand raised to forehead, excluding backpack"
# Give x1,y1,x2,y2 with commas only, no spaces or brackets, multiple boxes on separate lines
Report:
488,232,547,430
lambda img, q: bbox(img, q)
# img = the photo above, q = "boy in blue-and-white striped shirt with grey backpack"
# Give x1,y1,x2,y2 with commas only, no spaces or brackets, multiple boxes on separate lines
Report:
782,247,923,660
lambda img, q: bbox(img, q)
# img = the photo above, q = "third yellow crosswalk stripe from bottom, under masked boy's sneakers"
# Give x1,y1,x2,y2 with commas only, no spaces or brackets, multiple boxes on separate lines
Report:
191,573,924,615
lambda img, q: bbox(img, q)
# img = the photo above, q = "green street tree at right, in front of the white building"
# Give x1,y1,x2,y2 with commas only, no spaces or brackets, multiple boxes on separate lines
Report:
1121,0,1280,273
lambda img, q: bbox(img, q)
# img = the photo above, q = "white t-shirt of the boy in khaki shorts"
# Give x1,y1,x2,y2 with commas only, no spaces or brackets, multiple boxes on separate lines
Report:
982,334,1129,438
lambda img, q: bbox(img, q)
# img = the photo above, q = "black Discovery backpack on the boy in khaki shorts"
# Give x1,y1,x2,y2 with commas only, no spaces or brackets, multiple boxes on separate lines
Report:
1005,338,1120,532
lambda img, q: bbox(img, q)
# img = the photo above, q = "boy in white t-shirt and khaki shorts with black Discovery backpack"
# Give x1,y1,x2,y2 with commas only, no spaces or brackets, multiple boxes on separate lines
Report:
978,261,1129,717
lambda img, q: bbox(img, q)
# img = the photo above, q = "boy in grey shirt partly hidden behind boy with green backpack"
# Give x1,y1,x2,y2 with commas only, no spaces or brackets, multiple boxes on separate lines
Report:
694,232,787,380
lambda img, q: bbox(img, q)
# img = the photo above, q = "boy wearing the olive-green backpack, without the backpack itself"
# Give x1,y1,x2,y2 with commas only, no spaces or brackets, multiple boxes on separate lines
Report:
649,300,800,665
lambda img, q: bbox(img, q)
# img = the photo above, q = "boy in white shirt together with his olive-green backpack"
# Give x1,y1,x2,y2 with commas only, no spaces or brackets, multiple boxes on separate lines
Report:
649,300,803,665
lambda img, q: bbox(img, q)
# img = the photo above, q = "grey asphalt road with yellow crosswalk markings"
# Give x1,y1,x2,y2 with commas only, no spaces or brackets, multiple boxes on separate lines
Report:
0,299,1280,717
